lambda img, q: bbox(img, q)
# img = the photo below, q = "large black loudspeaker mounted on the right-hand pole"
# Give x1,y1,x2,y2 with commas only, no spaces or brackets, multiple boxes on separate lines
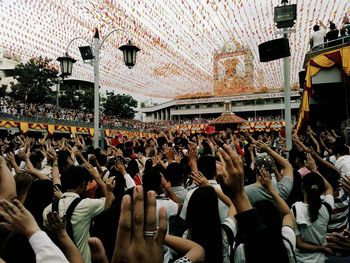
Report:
259,38,290,62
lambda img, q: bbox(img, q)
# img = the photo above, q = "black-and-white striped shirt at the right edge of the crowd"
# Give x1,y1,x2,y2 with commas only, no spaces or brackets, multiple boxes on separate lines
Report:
327,188,350,233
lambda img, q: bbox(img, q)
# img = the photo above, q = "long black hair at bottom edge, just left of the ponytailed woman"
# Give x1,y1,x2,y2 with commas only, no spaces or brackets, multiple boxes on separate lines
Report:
252,200,289,262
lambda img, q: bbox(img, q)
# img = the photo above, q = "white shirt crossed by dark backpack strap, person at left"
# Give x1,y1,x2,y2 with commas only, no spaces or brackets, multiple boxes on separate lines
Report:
43,192,105,263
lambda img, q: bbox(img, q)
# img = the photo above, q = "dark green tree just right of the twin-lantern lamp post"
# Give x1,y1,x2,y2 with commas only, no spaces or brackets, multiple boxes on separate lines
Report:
103,92,137,119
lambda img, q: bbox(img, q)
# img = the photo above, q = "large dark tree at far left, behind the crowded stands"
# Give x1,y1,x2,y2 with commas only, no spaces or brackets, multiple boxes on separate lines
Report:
10,57,58,103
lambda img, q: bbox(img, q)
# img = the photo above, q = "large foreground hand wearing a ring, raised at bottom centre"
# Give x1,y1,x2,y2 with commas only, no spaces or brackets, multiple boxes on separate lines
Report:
112,186,167,263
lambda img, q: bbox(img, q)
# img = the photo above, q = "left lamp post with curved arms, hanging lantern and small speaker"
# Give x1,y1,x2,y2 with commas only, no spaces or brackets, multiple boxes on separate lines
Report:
57,29,140,148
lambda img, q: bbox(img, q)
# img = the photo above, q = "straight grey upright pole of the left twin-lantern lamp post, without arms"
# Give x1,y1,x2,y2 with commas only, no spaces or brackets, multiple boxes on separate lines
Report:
94,29,100,148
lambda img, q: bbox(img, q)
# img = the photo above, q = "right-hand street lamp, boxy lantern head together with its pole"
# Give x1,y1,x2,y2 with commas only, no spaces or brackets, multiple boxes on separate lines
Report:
274,0,297,152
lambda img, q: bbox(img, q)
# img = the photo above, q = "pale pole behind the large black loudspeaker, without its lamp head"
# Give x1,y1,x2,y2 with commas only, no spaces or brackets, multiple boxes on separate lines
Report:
283,28,292,151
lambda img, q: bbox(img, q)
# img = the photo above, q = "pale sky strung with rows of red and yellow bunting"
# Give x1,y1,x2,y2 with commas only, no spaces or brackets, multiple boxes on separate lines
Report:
0,0,350,103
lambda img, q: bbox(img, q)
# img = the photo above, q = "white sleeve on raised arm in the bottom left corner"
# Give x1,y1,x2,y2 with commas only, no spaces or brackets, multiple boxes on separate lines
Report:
29,231,69,263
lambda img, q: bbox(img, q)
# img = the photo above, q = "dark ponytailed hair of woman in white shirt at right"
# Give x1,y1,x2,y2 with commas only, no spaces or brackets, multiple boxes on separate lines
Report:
303,173,325,222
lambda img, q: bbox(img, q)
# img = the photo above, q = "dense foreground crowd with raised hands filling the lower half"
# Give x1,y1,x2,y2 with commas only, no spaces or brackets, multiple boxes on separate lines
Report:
0,126,350,263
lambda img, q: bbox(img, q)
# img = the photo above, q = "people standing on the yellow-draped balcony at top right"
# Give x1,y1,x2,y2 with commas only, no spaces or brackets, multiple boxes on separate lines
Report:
310,15,350,51
